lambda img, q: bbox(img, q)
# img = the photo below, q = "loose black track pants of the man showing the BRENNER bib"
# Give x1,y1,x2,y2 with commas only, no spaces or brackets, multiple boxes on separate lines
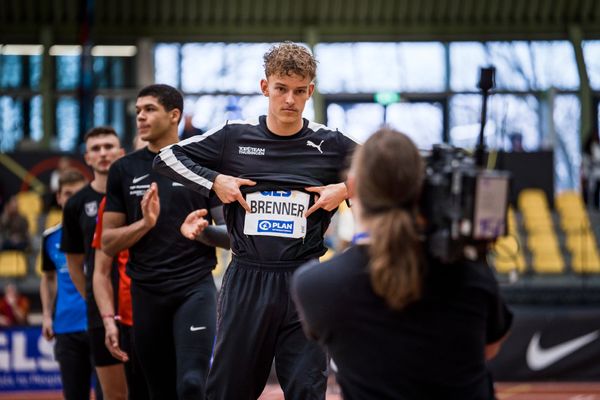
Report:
207,258,327,400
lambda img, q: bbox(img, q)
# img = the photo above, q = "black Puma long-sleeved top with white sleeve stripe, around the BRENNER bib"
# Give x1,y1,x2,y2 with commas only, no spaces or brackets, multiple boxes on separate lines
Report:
154,116,357,265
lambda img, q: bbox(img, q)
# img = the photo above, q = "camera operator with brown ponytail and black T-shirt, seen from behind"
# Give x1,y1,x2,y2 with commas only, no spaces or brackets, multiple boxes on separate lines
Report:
293,129,512,400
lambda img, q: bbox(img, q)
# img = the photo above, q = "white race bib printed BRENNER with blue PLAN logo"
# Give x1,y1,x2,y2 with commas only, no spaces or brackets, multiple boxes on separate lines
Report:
244,190,310,239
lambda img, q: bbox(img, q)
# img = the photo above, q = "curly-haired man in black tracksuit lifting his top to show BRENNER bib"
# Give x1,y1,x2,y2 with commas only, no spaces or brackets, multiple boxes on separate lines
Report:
154,42,356,400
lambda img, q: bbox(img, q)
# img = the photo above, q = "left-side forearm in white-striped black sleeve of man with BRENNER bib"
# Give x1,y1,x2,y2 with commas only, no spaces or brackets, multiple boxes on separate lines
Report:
153,145,218,197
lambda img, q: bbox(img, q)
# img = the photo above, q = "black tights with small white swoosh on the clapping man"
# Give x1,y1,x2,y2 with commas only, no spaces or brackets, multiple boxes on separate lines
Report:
131,274,216,400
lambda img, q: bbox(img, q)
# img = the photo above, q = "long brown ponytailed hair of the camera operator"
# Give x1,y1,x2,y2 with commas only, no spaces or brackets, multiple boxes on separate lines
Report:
354,128,423,310
